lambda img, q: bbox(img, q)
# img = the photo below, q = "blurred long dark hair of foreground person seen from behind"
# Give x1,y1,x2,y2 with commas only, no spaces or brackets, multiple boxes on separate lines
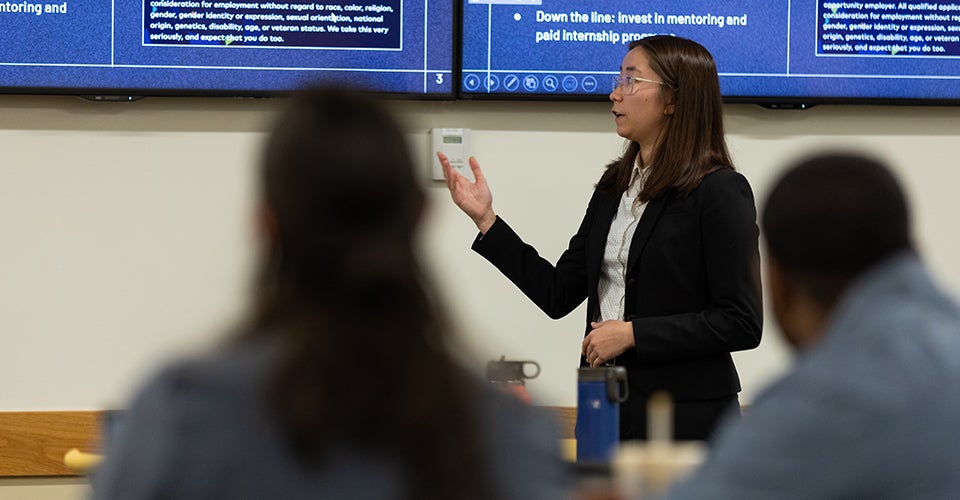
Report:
249,88,489,499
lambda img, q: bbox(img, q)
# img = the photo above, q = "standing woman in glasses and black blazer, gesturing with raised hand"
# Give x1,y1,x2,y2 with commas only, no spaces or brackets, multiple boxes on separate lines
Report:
438,36,762,440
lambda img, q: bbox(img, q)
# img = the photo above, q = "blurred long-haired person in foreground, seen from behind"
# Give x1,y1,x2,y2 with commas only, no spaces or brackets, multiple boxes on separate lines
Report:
93,88,565,500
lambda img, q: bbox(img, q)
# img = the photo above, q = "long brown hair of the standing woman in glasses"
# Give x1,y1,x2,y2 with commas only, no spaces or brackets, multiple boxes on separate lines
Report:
597,35,733,201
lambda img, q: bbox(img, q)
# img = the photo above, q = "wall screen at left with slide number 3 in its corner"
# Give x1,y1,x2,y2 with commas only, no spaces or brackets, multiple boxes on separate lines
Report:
0,0,456,98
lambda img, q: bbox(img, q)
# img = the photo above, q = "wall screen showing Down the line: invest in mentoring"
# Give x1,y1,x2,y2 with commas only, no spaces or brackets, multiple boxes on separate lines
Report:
459,0,960,107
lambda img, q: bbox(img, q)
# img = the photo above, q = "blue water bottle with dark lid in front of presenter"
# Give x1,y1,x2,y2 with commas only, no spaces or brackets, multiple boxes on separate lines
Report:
575,366,628,463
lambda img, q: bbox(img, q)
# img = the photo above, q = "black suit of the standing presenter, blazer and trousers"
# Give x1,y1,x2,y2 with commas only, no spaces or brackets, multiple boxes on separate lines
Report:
473,169,763,434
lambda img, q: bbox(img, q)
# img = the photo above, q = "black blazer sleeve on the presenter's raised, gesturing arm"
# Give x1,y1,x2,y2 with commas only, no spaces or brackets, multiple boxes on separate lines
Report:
471,194,597,319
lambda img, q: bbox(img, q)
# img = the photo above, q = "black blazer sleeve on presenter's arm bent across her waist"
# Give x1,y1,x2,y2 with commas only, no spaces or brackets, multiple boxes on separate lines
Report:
631,170,763,359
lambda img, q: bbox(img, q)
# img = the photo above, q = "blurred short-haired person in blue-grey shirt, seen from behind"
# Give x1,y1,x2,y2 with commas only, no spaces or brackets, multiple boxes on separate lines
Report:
667,153,960,500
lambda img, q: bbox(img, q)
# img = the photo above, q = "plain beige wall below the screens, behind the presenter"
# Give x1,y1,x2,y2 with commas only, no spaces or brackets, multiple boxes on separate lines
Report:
0,96,960,499
